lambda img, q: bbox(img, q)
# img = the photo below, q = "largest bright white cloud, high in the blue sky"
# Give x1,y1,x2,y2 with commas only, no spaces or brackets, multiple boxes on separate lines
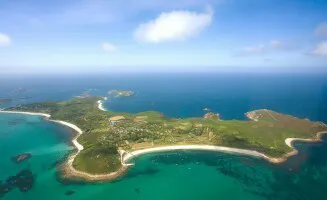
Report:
134,8,213,43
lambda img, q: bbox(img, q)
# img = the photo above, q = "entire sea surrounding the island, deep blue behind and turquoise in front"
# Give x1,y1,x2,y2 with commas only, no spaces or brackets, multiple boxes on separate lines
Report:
0,73,327,200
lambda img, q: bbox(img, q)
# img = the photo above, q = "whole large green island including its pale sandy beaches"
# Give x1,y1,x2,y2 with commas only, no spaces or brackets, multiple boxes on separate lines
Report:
0,96,327,181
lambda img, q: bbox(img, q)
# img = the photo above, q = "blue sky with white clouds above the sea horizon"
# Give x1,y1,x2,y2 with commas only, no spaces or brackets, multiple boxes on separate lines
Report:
0,0,327,73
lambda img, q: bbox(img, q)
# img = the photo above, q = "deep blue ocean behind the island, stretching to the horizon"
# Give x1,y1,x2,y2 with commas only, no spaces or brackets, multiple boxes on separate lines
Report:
0,73,327,122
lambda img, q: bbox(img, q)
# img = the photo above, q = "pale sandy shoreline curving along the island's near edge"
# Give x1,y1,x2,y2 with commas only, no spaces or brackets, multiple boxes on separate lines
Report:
0,108,327,182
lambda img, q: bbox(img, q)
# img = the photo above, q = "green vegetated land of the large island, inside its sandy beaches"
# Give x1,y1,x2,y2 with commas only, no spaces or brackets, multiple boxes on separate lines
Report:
6,97,327,174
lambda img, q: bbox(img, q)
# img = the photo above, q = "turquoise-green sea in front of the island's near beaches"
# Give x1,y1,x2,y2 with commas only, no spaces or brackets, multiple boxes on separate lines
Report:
0,114,327,200
